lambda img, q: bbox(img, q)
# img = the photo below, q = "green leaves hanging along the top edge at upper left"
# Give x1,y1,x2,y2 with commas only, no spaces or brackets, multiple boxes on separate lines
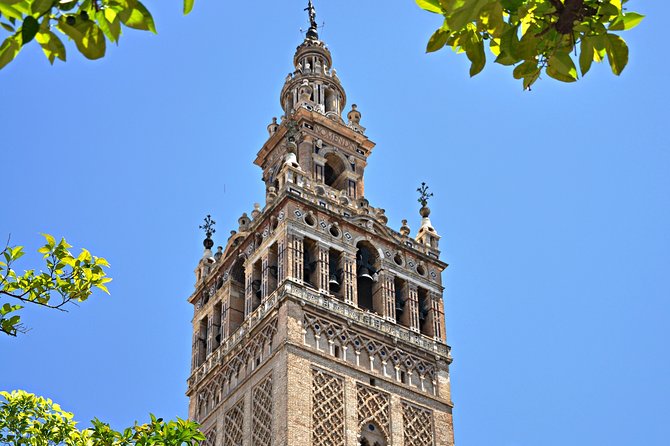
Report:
0,0,194,69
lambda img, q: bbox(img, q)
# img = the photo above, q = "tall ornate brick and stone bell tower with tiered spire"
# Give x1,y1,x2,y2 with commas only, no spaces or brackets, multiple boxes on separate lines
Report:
187,1,453,446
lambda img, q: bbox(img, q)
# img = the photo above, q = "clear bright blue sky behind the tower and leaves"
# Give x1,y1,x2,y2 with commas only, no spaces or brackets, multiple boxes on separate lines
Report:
0,0,670,446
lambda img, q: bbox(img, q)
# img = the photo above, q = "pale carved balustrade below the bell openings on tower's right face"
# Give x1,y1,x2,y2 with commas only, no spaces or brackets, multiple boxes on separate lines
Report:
284,281,451,360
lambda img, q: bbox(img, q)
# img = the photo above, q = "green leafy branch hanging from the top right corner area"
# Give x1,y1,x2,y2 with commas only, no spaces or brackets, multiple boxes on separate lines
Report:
416,0,644,89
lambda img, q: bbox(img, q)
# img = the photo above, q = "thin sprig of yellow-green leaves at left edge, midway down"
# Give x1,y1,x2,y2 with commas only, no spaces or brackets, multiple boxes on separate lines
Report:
0,234,112,336
